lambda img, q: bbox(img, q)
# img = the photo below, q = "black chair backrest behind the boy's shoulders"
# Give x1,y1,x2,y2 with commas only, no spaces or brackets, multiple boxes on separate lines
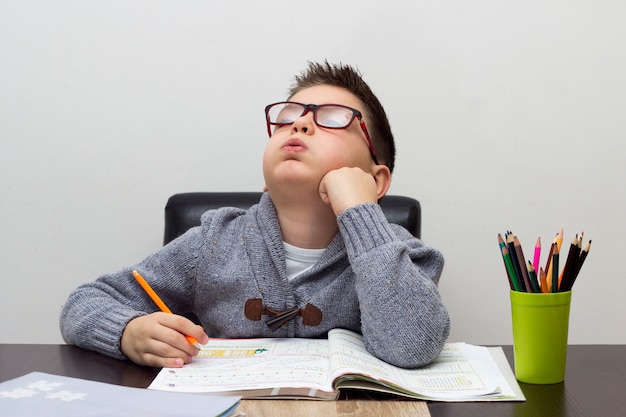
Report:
163,192,422,244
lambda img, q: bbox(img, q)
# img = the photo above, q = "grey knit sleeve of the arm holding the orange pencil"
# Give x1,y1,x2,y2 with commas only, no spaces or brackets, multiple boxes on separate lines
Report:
60,228,204,359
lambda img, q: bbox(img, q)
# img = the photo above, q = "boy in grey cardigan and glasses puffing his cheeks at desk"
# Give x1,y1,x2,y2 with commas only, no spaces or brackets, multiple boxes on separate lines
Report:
61,62,450,368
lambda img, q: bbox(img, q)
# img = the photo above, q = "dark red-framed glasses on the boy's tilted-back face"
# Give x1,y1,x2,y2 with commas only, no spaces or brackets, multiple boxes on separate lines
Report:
265,101,378,165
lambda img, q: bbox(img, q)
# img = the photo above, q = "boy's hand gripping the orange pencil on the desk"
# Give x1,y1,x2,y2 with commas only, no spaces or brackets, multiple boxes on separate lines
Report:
121,312,209,368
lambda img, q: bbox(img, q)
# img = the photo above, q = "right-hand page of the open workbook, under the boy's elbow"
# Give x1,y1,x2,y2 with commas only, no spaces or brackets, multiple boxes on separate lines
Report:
329,329,508,400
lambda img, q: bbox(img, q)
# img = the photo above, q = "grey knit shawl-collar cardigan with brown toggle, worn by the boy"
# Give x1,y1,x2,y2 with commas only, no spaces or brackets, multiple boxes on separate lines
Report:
60,193,450,368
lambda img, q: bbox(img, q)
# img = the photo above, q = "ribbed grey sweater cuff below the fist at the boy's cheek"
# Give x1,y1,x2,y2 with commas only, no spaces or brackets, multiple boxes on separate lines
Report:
337,203,395,253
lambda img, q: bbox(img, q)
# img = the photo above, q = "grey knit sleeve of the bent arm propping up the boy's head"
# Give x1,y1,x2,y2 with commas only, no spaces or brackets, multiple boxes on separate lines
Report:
337,203,450,368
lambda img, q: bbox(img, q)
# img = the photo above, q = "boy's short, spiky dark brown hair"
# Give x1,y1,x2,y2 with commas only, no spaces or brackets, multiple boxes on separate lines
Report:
289,61,396,172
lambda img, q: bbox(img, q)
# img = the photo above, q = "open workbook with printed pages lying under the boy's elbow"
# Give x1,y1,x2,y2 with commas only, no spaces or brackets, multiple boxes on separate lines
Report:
148,329,525,401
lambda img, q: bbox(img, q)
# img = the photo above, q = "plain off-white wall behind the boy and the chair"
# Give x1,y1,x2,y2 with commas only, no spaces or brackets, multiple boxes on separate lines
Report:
0,0,626,344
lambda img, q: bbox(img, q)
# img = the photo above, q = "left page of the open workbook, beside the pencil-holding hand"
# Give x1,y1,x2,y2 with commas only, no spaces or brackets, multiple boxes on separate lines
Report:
148,338,332,396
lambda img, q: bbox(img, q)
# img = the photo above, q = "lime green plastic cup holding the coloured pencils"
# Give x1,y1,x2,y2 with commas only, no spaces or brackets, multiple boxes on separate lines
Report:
511,291,572,384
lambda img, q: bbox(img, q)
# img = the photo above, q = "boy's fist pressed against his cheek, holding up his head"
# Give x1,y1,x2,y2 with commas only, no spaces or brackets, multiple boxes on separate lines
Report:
319,167,378,216
